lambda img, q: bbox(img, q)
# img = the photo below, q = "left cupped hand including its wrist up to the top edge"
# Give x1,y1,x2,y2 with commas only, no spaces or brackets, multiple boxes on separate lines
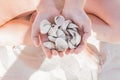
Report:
32,0,59,58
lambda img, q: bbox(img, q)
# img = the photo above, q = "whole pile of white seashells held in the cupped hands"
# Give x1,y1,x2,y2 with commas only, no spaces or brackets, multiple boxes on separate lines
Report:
40,15,81,51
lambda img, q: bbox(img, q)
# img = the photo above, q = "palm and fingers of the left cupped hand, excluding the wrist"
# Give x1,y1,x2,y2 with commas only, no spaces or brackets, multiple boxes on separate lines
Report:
32,9,59,58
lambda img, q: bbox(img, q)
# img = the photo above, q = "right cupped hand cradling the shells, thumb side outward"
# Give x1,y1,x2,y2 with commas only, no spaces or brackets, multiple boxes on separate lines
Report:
62,4,91,54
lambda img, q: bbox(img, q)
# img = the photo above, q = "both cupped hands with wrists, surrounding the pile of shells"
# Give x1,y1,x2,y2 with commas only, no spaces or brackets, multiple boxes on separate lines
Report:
32,0,91,58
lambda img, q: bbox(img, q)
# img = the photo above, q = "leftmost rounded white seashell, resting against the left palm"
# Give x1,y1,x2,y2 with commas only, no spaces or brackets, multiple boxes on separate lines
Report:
40,20,51,34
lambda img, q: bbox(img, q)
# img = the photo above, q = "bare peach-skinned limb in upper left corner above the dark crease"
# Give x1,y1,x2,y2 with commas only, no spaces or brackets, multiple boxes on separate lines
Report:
0,0,40,26
